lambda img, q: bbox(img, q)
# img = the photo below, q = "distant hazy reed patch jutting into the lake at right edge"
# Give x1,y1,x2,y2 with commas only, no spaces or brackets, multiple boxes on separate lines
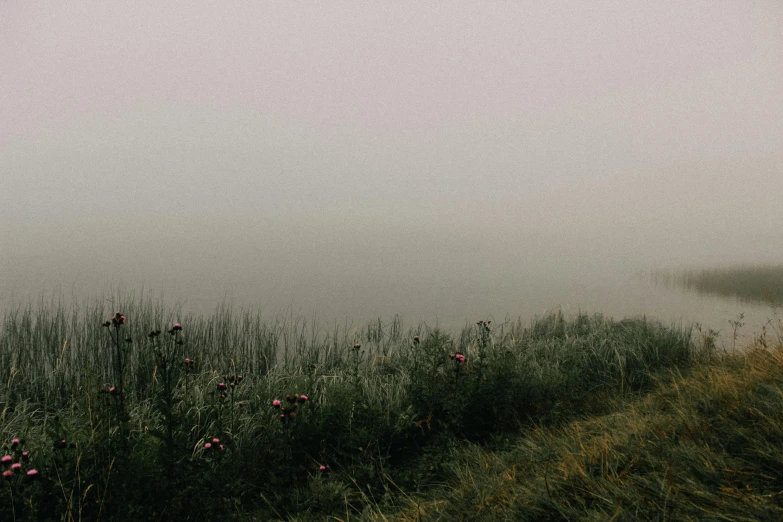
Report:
652,265,783,305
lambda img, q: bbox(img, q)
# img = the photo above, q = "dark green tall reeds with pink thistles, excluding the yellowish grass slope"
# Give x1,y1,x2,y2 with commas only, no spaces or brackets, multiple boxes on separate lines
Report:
0,300,698,520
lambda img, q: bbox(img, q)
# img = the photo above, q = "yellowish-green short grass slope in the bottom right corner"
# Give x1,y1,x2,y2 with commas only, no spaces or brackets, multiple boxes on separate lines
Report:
384,346,783,521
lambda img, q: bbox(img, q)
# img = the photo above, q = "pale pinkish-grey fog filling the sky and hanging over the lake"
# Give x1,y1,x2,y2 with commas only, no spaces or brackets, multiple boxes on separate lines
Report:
0,1,783,326
